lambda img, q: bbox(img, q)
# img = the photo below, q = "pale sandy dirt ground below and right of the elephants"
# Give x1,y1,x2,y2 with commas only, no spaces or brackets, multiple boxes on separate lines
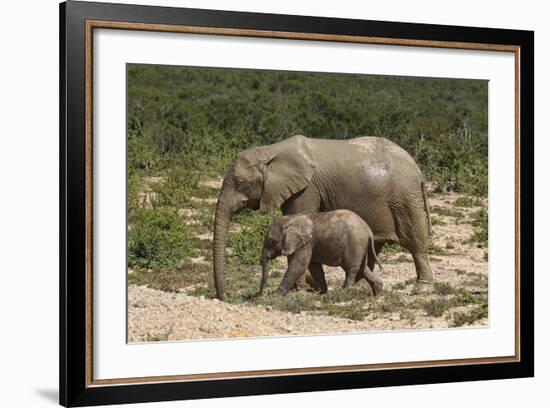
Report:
128,181,488,342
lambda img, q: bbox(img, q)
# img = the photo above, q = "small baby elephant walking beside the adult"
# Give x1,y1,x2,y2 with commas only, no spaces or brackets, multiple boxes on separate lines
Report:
260,210,383,295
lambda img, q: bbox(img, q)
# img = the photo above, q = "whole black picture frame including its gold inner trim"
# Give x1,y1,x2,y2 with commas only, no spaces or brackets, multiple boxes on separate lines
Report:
59,1,534,406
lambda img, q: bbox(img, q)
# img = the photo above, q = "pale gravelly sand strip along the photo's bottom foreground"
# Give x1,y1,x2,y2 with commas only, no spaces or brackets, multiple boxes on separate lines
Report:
128,286,484,342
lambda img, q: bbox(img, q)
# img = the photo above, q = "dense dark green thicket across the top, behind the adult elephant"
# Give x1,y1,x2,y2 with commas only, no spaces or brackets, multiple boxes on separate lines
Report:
128,64,488,195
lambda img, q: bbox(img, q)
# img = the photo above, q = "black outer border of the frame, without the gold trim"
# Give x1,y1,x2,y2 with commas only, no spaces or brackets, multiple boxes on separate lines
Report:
59,1,534,406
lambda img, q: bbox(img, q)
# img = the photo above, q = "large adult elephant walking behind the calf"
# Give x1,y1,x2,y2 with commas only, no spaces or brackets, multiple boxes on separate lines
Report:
213,136,433,300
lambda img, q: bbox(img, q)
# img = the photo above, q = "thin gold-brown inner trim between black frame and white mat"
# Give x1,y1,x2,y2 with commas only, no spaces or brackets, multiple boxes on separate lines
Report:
85,20,521,388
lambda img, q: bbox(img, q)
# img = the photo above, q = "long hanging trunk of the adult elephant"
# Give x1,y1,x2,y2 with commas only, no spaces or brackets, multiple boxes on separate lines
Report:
213,190,233,300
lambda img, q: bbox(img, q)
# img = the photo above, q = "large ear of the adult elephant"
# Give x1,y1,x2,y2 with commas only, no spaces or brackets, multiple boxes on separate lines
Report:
260,136,315,212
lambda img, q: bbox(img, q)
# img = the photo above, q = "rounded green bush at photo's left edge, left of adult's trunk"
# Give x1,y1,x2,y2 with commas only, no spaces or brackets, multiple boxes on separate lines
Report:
128,207,193,268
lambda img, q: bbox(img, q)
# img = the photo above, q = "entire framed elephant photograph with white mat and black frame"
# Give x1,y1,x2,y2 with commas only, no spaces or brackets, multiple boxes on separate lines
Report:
60,1,534,406
